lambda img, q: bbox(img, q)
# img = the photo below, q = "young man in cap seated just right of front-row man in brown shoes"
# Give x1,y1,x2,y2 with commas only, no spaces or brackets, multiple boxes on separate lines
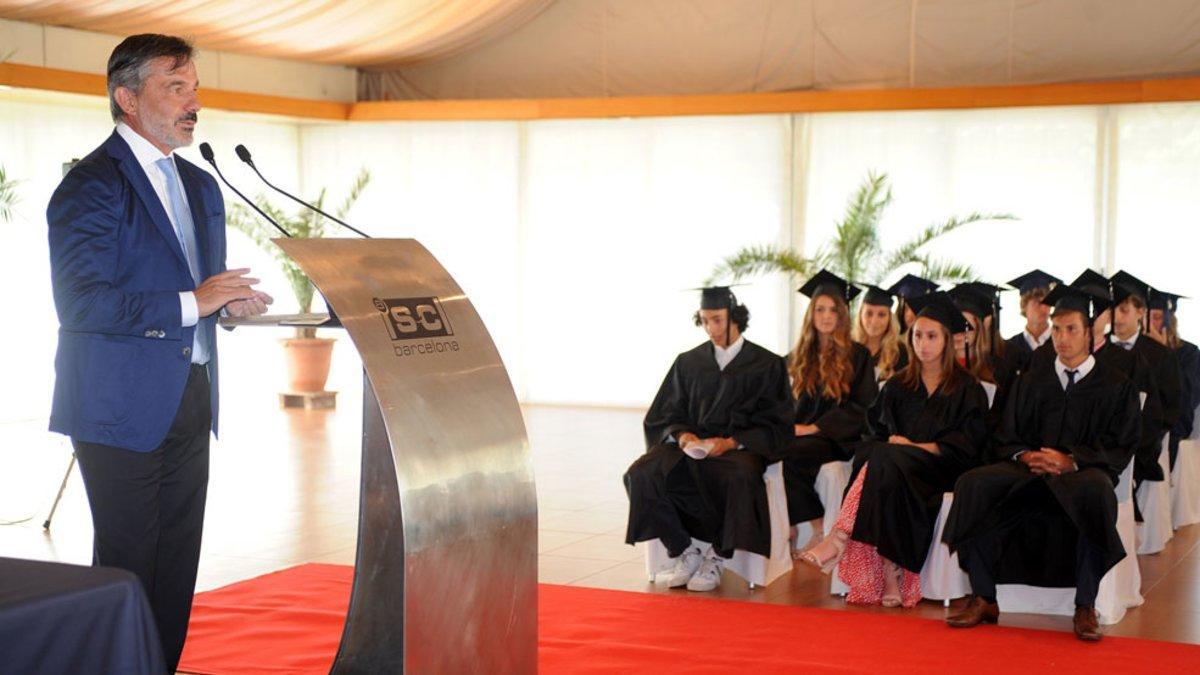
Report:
1109,271,1182,485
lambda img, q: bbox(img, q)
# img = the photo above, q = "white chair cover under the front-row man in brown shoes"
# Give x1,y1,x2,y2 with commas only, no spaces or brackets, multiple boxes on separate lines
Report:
996,460,1145,626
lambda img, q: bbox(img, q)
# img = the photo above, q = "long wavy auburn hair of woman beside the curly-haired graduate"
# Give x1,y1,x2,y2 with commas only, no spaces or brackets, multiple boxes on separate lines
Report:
787,294,854,401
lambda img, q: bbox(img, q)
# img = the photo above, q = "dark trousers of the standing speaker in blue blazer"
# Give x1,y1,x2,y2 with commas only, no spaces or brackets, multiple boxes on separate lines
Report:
72,365,212,673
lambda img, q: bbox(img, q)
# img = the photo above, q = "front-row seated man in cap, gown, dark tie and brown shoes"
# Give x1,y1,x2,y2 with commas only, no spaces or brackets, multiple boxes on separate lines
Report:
943,286,1139,640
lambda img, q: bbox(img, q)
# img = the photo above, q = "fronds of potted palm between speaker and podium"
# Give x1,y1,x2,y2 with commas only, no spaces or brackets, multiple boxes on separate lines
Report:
226,168,371,338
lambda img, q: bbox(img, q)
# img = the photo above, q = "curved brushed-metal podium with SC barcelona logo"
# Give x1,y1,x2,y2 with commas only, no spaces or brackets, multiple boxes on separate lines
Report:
226,239,538,673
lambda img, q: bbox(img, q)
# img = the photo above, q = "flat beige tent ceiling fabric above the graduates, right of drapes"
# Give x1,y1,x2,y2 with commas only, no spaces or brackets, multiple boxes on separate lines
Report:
359,0,1200,100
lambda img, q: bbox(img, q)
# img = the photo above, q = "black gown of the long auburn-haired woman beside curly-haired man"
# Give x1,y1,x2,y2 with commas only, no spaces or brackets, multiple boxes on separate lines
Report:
775,342,878,525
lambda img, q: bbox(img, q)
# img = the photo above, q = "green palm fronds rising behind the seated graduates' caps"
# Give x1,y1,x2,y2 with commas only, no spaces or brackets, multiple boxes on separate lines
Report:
706,172,1015,286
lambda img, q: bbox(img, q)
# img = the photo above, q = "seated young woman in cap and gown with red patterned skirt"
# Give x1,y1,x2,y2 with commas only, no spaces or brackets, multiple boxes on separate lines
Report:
802,293,988,607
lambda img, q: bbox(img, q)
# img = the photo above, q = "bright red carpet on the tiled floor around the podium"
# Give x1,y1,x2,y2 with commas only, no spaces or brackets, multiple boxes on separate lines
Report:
180,565,1200,675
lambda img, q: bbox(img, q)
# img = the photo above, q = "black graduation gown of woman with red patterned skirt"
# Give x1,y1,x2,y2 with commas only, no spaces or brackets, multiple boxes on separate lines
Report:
851,375,988,573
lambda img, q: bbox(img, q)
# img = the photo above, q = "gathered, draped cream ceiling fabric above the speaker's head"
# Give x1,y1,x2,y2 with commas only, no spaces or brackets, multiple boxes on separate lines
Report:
0,0,553,66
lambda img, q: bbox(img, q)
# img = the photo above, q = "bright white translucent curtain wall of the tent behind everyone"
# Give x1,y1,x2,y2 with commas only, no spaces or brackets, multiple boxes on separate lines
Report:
0,90,1200,422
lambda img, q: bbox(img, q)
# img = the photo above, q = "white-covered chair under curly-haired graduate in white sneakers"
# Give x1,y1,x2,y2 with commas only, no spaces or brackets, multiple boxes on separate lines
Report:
643,461,792,590
